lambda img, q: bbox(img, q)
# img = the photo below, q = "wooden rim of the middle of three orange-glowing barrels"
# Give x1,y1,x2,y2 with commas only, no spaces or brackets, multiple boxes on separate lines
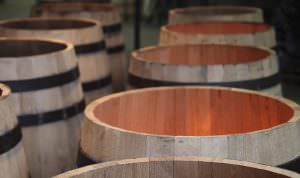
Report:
130,43,276,67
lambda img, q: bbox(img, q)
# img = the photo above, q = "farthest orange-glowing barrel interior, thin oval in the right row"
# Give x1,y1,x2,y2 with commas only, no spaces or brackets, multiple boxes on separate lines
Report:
166,22,272,35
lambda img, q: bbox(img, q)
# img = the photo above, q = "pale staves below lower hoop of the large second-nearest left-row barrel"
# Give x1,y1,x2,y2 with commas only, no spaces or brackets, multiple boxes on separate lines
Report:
22,114,83,178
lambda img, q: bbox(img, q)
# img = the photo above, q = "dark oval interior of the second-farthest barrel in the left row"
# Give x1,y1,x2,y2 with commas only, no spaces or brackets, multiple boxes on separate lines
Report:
1,19,96,30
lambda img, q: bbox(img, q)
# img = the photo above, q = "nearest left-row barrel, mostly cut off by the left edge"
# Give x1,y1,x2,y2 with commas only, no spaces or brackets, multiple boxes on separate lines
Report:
0,84,29,178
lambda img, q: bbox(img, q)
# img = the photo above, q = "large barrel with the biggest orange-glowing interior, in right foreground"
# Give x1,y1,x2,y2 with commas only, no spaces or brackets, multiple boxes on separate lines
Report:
78,87,300,171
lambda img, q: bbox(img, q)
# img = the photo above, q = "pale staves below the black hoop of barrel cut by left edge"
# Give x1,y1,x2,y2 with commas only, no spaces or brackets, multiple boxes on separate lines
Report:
0,142,30,178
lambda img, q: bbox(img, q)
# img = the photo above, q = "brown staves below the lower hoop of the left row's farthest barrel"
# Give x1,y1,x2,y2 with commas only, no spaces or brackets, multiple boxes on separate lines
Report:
110,52,128,92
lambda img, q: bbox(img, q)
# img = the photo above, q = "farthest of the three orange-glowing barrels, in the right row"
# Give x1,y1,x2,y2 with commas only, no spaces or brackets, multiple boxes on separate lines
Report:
160,22,276,48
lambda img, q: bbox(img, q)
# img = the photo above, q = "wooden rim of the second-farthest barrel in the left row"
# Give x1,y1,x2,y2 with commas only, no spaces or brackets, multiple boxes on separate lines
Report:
0,17,102,32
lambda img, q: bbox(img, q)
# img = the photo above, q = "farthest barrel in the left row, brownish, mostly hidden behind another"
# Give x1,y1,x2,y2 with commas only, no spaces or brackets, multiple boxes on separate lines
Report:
32,2,127,91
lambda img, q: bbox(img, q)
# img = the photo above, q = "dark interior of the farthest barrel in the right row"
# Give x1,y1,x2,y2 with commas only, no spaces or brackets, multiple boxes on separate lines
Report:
172,7,257,16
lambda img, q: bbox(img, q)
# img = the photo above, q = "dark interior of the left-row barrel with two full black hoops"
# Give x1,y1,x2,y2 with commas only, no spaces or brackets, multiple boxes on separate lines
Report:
0,39,67,58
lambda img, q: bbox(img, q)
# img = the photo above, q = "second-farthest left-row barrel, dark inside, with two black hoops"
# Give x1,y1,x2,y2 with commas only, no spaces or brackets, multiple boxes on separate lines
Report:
0,18,112,103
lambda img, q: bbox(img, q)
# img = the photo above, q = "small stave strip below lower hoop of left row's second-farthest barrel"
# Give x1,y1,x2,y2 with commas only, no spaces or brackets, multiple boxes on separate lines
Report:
84,85,112,104
